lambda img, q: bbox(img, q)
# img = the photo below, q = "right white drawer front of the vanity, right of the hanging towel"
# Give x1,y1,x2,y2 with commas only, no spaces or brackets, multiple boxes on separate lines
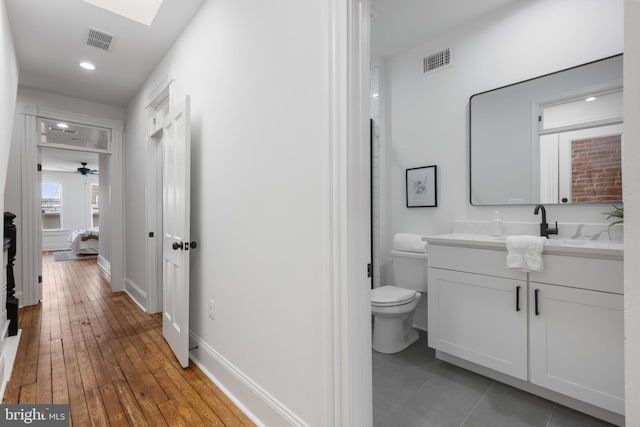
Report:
529,254,624,294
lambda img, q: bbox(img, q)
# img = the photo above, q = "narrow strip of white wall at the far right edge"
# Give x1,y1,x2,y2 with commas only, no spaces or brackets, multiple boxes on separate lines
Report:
622,0,640,426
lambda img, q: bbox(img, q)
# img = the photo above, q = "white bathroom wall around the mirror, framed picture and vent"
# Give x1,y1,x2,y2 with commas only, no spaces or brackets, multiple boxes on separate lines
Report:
382,0,623,281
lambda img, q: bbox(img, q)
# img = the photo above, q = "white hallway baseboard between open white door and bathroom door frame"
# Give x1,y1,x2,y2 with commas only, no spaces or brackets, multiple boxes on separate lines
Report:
189,332,308,427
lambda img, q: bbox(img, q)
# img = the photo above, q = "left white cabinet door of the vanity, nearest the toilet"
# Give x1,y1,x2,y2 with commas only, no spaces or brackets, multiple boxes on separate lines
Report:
428,268,527,380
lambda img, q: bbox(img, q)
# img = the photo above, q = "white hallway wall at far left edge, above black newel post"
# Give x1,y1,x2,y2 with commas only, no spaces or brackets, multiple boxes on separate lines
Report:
0,2,18,251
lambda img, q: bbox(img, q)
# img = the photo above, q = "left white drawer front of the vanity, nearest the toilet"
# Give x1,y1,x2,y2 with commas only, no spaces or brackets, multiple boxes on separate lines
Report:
427,243,527,280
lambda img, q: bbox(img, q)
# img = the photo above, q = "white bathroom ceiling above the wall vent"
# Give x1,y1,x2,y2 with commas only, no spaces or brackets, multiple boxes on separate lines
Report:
371,0,523,58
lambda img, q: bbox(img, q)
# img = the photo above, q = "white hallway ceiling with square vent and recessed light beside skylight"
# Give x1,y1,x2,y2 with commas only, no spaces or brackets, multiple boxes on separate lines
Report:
3,0,205,106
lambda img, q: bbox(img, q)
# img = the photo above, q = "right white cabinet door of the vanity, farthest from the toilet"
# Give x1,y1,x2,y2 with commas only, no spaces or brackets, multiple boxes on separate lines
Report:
529,282,624,414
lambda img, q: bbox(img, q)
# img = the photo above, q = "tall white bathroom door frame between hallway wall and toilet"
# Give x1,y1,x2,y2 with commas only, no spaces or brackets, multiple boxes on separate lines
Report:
325,0,373,426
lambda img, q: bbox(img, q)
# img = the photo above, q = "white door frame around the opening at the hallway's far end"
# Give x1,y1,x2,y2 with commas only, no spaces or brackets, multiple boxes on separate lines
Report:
18,103,125,306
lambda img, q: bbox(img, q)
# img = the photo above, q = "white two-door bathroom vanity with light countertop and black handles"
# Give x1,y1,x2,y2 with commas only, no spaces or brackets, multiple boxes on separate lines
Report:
425,233,624,424
